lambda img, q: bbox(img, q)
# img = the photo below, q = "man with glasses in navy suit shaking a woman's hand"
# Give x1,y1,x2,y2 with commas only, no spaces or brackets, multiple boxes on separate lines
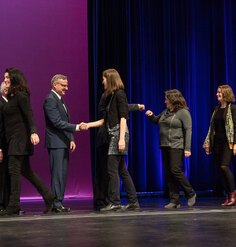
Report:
43,74,80,213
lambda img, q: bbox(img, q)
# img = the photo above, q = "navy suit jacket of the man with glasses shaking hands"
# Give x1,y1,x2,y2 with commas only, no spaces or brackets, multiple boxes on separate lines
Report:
43,91,76,148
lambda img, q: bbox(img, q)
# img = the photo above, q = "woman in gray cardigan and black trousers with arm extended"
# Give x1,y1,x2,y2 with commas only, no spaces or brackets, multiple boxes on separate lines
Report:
146,89,196,209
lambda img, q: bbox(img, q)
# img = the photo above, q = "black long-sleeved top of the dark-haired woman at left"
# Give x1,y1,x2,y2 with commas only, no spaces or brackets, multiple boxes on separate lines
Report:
3,92,37,155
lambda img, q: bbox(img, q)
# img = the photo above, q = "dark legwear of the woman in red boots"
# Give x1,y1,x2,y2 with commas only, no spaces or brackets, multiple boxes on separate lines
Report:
213,142,235,193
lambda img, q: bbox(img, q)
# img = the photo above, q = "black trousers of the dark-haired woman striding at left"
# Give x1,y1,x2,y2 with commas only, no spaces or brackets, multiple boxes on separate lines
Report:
8,155,50,209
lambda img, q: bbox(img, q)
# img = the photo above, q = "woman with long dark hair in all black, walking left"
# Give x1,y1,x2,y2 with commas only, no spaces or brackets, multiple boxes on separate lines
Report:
0,68,55,215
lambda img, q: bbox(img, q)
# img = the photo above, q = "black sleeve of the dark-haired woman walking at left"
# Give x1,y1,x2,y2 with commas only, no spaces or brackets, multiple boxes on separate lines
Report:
17,92,37,134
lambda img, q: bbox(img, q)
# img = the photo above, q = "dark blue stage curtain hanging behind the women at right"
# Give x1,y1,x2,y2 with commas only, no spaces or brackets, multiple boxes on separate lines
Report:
88,0,236,192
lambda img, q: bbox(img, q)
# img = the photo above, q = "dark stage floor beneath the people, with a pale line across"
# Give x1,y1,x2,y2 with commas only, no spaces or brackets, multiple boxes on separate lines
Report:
0,197,236,247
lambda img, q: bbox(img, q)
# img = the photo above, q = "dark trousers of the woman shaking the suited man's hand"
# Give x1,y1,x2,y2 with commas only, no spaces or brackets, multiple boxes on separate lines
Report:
107,155,137,205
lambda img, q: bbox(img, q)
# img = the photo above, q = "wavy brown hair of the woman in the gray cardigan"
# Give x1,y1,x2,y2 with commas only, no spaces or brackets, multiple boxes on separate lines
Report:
165,89,188,111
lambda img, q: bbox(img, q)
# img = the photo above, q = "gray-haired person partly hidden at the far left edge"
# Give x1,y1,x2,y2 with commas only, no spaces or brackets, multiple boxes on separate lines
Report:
0,82,10,210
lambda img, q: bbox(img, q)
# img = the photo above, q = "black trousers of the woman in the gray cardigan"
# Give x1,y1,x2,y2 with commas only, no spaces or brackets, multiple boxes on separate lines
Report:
161,147,195,203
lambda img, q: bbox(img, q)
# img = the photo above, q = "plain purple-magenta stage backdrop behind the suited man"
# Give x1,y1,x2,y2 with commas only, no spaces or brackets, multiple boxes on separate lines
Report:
0,0,92,197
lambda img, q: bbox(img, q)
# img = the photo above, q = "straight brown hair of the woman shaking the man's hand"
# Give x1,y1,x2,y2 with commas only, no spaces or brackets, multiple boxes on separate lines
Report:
102,69,125,96
